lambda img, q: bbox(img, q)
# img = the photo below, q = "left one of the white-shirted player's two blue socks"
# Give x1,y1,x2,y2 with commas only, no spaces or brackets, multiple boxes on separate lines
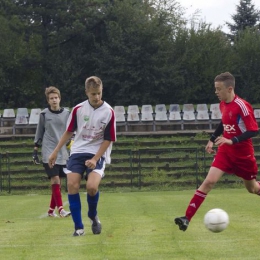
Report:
68,193,84,229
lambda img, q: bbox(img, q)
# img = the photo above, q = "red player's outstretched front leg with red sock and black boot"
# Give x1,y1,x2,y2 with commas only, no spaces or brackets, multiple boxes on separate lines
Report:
175,166,224,231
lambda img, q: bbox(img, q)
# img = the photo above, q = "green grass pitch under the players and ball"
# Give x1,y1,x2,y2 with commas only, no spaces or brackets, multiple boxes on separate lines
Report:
0,189,260,260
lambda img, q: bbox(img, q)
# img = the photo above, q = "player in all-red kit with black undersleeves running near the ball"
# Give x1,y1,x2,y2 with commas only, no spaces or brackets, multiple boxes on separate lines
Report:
175,72,260,231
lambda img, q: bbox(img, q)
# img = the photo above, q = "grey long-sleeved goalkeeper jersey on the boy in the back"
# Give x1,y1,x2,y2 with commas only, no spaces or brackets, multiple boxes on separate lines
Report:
34,108,70,165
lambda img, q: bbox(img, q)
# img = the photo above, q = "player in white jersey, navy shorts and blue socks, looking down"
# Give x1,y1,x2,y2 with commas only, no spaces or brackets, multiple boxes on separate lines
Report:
49,76,116,236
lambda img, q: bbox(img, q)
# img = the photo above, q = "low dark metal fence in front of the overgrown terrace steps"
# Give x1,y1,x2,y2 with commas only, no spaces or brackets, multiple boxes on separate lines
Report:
0,148,211,193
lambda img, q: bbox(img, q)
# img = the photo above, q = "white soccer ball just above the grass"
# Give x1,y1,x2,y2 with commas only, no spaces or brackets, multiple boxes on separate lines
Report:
204,209,229,233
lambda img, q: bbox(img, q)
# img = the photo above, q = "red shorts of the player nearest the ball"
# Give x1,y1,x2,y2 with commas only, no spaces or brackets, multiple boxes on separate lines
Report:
211,149,258,180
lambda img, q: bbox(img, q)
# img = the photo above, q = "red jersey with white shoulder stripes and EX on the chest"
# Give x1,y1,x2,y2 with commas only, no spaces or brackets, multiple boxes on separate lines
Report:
219,95,258,154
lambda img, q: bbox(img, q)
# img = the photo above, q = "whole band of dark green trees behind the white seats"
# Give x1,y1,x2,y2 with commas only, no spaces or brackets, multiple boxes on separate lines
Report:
0,0,260,109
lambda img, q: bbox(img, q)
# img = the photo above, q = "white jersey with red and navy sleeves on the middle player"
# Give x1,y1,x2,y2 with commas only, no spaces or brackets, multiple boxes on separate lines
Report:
67,100,116,164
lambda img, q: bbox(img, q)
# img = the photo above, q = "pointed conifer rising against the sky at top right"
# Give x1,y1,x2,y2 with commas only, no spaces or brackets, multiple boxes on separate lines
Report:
226,0,260,35
